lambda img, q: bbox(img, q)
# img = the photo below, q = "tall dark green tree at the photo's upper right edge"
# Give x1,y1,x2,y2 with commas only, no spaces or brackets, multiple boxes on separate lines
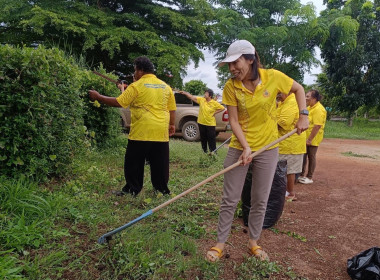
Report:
320,0,380,117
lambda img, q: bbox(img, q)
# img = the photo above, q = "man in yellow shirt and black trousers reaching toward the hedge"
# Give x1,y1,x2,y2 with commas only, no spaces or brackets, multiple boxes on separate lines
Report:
89,56,176,195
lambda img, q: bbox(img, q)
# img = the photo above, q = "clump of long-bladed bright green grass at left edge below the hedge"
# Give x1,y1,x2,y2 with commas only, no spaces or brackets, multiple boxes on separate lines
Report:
0,178,67,252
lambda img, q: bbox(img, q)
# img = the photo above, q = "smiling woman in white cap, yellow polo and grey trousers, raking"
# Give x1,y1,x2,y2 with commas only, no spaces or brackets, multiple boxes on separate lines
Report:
206,40,308,261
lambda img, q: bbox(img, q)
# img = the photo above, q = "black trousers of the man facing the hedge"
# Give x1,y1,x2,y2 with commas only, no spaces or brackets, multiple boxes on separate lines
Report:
122,140,170,195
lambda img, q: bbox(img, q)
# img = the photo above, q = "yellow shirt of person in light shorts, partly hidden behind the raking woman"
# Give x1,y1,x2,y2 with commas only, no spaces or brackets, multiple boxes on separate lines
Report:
277,93,306,155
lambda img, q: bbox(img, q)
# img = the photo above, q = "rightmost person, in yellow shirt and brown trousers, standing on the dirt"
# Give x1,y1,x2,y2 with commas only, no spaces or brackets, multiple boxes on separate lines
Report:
298,89,327,184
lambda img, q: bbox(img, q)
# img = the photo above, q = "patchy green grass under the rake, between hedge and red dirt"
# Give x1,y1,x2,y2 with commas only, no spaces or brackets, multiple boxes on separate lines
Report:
0,137,298,280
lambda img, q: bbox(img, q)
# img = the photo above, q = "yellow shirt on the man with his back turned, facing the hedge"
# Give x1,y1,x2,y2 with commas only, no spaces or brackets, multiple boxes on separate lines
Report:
116,74,177,142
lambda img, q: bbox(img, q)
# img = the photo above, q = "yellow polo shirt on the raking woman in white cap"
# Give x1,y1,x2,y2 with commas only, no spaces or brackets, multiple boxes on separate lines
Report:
222,69,293,151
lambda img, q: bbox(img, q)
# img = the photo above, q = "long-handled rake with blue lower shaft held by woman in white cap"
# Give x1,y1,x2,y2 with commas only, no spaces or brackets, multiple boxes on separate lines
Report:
98,128,297,244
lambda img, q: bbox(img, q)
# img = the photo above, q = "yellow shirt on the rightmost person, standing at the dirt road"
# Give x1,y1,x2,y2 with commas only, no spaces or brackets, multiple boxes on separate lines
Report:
306,101,327,146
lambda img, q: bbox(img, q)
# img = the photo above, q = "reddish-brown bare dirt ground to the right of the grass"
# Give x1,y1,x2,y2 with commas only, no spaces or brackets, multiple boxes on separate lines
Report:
204,134,380,280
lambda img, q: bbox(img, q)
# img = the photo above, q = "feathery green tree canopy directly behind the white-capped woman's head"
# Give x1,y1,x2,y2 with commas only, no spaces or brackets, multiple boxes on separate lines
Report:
209,0,327,86
